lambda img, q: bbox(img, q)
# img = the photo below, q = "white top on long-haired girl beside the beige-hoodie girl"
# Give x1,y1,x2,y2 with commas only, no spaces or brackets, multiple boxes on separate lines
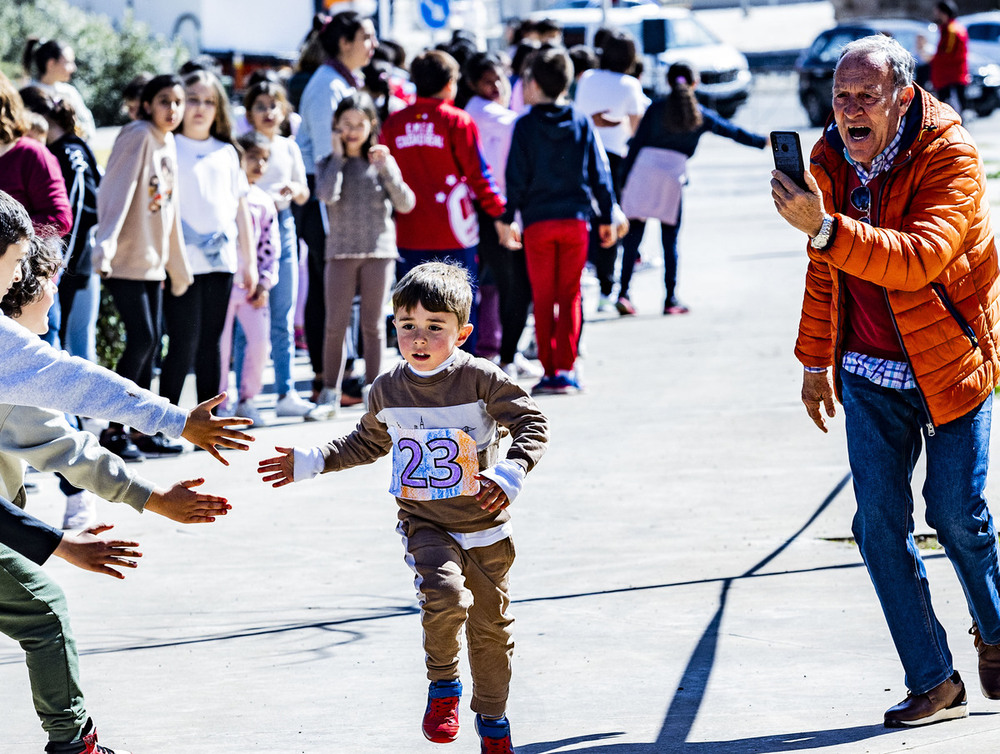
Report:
175,134,249,275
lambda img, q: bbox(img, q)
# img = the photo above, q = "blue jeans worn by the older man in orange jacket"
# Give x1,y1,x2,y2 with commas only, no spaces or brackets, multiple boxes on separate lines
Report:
840,370,1000,694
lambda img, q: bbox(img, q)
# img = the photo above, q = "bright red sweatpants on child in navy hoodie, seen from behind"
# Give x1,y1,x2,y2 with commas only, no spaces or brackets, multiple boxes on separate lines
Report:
524,220,589,376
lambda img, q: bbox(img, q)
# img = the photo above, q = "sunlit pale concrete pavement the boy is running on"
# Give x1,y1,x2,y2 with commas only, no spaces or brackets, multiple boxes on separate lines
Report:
9,72,1000,754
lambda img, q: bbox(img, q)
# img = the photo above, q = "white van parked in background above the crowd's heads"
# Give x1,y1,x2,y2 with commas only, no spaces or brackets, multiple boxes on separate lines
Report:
530,3,751,118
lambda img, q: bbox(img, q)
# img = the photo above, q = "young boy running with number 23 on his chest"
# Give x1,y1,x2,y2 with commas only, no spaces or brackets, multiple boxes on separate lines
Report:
257,262,548,754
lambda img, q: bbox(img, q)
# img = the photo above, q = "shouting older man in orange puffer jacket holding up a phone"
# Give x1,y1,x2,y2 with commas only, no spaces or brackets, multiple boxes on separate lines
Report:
771,36,1000,727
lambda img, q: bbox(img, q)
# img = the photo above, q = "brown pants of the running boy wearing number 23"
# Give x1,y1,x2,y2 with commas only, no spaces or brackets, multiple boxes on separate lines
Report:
397,517,514,717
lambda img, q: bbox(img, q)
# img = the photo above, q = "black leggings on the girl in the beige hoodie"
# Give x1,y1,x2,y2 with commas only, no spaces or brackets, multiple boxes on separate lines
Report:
104,278,163,390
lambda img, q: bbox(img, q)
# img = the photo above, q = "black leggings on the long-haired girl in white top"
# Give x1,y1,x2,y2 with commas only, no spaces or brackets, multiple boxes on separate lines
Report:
160,272,233,405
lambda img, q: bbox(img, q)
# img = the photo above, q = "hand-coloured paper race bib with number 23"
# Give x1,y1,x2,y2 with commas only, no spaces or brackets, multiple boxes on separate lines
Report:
389,427,479,500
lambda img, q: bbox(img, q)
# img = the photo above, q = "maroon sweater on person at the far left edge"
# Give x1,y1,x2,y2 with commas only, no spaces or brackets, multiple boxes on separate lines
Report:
0,136,73,236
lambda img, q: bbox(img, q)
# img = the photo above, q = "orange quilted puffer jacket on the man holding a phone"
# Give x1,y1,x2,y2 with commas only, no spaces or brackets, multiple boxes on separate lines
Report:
795,88,1000,425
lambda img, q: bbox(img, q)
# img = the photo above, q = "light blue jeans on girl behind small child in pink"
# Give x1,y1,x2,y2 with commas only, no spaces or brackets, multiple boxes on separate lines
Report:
233,209,299,396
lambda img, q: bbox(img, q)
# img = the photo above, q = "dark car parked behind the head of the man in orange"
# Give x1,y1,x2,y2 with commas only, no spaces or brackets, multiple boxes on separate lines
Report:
795,18,1000,126
